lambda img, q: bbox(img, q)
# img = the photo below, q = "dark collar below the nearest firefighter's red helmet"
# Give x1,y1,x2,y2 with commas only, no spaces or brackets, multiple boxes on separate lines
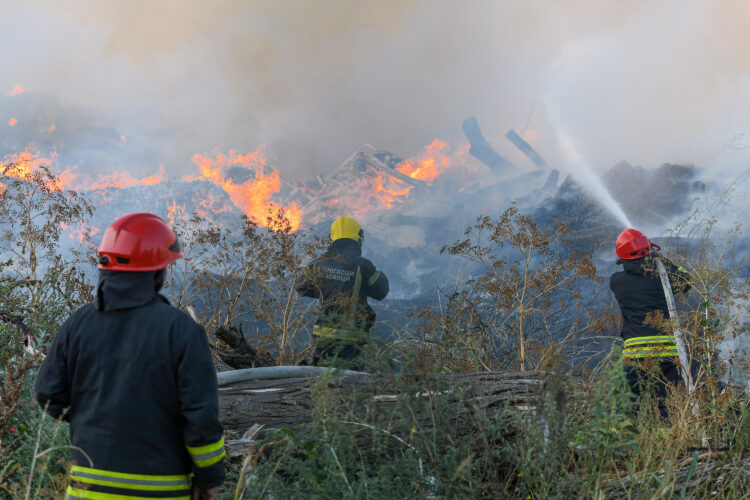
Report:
96,270,168,312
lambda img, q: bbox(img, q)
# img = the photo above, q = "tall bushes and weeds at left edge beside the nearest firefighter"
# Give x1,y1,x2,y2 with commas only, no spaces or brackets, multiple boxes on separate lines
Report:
0,163,92,498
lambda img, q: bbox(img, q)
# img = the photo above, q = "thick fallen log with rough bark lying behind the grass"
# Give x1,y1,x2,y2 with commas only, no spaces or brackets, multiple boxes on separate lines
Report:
219,367,563,435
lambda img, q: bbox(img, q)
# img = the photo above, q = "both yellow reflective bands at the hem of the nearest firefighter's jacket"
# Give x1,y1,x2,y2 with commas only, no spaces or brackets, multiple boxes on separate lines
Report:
66,465,190,500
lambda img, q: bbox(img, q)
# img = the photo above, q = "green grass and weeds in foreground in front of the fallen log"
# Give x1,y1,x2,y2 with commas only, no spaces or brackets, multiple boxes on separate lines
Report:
236,356,750,499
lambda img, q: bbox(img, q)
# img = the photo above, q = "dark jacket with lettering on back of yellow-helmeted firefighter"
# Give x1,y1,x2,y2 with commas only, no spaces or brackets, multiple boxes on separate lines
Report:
296,238,388,341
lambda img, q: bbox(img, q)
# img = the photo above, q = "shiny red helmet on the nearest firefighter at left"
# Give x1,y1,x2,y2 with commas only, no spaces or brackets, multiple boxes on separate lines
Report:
99,213,182,271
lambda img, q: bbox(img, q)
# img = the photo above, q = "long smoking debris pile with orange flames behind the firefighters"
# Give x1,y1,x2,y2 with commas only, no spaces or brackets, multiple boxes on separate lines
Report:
0,89,705,304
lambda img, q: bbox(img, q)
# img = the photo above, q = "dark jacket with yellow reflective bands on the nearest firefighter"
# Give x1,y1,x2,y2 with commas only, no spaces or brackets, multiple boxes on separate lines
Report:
35,271,225,498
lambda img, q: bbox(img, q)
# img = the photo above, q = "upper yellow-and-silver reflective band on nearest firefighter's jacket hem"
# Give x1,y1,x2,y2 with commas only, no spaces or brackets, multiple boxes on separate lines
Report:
70,465,190,491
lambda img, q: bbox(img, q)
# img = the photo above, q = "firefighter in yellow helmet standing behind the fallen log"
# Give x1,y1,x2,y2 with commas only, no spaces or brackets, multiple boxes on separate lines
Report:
296,216,388,368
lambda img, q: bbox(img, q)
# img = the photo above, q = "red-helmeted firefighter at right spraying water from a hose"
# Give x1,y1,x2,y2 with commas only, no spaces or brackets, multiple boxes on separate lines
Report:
609,229,690,418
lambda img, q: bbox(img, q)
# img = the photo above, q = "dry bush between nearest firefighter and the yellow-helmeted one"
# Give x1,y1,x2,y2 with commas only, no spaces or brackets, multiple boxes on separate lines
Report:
167,206,323,365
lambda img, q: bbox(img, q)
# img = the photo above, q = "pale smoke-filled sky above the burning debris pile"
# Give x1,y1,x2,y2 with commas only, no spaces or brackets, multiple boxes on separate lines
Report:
0,0,750,179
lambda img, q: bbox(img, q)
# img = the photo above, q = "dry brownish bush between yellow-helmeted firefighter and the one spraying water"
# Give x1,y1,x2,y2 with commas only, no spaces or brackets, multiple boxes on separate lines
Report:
394,206,599,371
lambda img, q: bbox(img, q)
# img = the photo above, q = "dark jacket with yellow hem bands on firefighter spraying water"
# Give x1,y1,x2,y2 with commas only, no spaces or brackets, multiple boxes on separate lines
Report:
609,256,690,358
